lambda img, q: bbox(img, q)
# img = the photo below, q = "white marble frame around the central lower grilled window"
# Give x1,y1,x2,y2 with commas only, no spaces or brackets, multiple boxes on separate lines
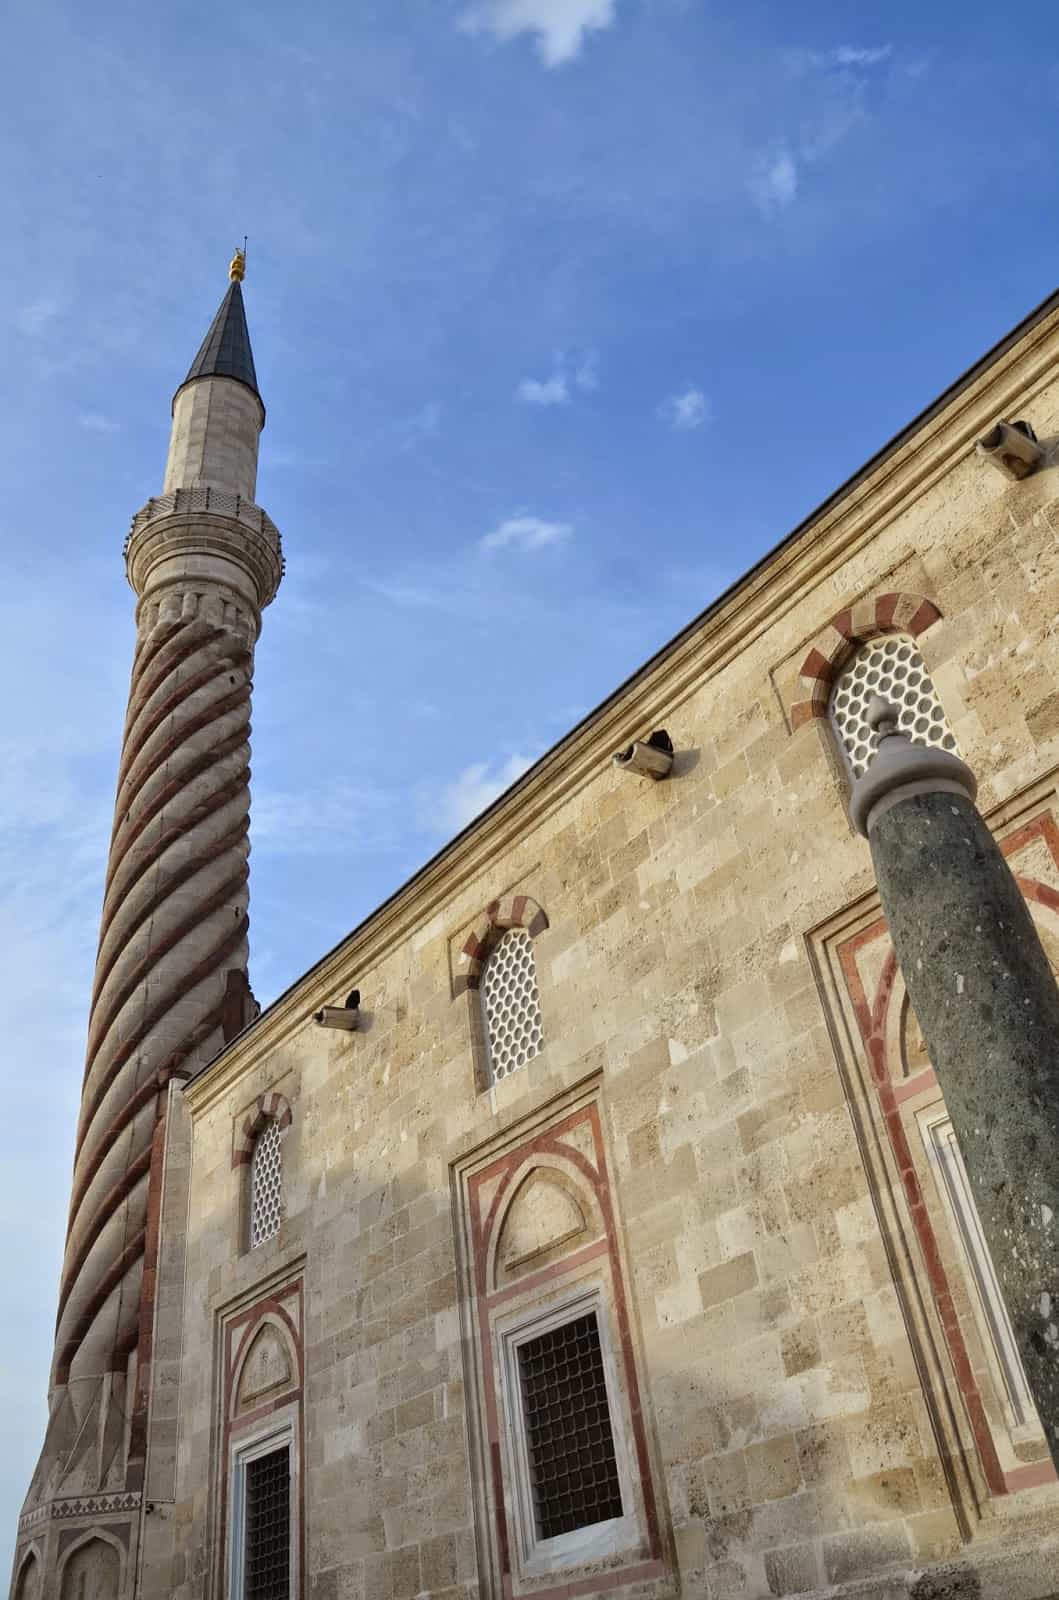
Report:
493,1282,646,1578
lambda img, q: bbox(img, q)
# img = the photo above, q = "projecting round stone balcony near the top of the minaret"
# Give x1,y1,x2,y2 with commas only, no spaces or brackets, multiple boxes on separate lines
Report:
123,485,283,610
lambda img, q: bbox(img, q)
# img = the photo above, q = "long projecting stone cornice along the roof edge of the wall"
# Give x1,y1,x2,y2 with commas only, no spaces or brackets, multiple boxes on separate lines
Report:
184,293,1059,1115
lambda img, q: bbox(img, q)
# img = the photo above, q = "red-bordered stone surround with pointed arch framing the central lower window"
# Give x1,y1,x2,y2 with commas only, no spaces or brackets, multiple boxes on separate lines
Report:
458,1085,669,1600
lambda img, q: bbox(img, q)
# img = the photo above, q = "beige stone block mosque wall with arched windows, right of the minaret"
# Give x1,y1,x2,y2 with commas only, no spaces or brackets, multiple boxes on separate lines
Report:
139,310,1059,1600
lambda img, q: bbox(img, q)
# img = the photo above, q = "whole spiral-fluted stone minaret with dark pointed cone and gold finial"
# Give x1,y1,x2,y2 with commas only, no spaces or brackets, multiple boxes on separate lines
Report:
16,251,283,1594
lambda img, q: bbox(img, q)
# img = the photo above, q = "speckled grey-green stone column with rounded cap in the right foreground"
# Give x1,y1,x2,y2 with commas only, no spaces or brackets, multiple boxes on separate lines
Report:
849,699,1059,1467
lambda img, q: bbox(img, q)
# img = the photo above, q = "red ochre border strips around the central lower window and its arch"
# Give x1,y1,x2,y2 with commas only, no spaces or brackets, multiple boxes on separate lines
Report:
467,1107,664,1600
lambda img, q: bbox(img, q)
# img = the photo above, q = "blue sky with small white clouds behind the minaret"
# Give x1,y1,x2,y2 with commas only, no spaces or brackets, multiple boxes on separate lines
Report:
0,0,1059,1558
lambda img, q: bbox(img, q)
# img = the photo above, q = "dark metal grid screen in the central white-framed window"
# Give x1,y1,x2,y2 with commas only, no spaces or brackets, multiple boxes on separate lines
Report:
518,1312,622,1539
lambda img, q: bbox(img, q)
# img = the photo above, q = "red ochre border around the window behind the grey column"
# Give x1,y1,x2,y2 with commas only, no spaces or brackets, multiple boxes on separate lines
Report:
838,816,1059,1494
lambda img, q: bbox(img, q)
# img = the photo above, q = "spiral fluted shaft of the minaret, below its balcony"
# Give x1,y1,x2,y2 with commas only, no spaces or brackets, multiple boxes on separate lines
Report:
53,592,251,1382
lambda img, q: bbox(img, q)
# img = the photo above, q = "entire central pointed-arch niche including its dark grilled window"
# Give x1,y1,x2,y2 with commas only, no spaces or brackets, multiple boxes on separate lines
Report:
458,1080,669,1600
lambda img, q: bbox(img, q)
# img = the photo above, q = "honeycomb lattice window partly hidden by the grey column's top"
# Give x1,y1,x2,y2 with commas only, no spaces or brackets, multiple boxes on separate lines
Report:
829,634,957,778
